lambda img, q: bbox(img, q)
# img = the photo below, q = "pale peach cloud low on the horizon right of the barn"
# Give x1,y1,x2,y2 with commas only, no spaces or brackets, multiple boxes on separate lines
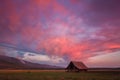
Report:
86,51,120,68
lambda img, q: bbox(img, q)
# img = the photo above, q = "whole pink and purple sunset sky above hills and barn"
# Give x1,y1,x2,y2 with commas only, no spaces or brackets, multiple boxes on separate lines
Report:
0,0,120,67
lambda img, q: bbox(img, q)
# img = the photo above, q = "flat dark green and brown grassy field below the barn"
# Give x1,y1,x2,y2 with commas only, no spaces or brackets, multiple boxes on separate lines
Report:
0,70,120,80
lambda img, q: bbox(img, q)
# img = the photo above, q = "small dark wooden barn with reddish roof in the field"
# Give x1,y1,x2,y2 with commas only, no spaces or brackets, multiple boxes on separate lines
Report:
66,61,88,72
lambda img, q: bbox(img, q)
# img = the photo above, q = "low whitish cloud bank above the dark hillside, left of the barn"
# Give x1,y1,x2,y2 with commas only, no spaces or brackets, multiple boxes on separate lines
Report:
22,52,65,64
